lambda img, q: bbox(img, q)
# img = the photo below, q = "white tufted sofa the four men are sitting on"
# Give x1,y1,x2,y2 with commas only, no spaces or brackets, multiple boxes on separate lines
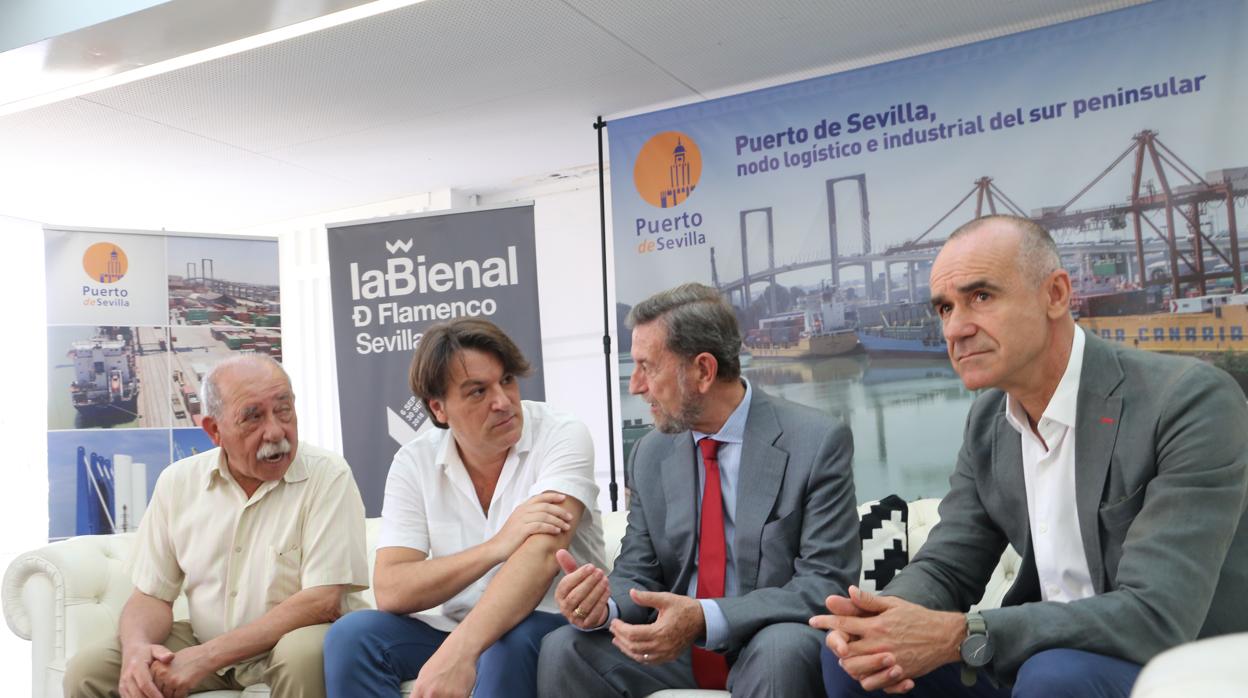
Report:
7,499,1018,698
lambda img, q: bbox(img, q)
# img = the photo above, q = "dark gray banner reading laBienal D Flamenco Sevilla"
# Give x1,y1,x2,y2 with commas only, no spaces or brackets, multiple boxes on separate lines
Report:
328,204,545,516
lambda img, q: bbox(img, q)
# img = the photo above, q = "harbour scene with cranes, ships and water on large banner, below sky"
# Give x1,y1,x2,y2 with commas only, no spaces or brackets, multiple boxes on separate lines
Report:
617,130,1248,499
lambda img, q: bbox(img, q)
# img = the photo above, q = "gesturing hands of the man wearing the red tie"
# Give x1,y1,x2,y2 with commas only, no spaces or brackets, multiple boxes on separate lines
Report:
554,551,706,664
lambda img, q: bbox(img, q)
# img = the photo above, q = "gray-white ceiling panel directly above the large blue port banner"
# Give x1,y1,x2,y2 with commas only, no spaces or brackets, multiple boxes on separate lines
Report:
565,0,1141,97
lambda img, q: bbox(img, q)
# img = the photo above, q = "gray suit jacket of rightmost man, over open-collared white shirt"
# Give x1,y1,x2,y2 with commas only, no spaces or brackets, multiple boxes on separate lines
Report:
885,332,1248,683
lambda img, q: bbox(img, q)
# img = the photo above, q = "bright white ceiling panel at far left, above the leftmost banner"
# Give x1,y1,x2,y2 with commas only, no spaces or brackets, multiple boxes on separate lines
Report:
0,100,373,230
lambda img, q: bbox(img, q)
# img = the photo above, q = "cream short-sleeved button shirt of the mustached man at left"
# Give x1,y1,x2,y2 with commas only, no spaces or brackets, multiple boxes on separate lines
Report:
131,442,368,642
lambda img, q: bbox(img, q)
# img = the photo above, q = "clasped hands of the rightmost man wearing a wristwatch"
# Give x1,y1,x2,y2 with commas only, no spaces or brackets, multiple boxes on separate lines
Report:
810,587,966,693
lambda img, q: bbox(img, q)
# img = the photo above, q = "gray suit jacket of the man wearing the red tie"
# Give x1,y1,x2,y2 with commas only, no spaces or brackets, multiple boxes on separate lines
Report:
610,386,860,657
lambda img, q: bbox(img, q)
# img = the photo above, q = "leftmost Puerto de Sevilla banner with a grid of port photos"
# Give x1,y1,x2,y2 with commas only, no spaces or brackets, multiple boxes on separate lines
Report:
45,229,282,539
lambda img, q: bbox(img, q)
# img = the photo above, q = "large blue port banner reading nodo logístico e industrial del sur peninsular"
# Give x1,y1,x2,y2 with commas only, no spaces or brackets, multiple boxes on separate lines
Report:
608,0,1248,499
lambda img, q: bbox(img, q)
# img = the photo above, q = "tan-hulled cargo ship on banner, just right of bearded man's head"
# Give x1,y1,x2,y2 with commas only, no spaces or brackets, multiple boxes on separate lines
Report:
745,291,859,358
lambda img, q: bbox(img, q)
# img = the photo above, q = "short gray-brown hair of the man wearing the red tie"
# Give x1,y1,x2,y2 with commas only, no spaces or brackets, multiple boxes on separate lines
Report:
625,283,741,381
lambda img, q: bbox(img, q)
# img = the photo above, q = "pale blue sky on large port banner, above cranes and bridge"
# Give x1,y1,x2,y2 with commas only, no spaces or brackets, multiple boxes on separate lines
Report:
608,0,1248,303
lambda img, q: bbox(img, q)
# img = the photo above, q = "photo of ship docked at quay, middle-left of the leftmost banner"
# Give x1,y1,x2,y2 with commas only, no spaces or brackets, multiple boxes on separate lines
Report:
47,326,171,430
